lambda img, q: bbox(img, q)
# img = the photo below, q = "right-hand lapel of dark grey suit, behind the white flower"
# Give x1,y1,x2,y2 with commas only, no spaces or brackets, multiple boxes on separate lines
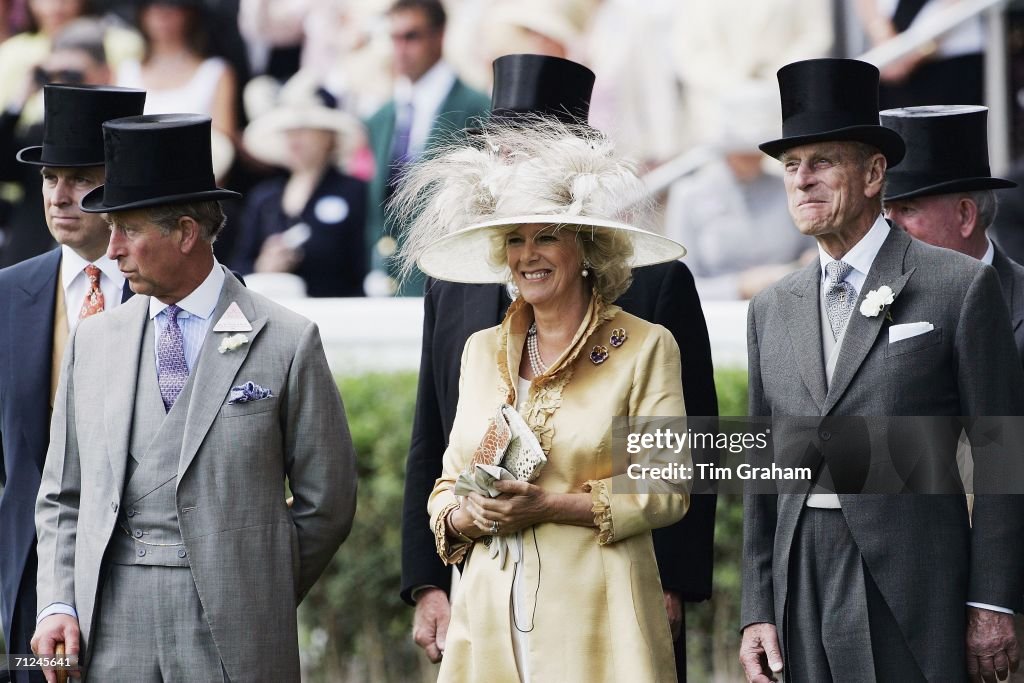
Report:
819,228,914,415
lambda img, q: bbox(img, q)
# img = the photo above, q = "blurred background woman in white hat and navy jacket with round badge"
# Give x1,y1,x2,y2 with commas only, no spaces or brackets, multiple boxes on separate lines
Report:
233,72,368,297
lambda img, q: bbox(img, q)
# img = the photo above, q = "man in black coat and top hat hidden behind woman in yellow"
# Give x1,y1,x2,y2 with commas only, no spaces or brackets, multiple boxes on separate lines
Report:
401,54,718,680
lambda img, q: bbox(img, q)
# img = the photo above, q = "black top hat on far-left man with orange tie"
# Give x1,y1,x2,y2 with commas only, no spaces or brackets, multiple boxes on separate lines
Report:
16,85,145,167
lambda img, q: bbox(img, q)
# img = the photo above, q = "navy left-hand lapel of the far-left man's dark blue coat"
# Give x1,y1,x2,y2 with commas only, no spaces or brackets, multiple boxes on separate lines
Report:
4,248,60,471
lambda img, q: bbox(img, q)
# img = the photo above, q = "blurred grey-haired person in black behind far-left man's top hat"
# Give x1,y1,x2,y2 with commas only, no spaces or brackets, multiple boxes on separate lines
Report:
0,19,111,266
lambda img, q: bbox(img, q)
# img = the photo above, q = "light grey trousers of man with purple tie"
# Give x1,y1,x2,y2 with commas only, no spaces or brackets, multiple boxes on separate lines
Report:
84,563,227,683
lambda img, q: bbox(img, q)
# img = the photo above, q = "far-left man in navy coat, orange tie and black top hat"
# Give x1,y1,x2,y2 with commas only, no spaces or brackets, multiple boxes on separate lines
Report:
0,85,145,681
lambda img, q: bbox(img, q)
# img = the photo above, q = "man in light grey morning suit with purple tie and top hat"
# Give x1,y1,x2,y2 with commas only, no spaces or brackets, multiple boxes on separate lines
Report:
33,115,355,683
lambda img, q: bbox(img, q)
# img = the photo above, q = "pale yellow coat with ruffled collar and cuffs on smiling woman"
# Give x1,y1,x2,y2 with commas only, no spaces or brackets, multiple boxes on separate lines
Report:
428,297,689,683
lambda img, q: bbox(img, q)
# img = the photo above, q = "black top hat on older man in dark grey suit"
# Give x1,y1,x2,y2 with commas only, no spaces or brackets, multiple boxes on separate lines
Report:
759,59,904,168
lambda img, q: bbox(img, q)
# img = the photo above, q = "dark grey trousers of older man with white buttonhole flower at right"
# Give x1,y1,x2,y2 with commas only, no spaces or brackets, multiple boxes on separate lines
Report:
782,508,925,683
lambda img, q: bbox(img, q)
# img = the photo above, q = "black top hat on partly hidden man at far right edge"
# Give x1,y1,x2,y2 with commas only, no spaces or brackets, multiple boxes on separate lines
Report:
881,104,1017,202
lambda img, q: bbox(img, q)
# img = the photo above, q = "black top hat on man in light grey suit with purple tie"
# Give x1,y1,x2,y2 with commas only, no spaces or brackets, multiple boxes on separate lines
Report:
82,114,242,213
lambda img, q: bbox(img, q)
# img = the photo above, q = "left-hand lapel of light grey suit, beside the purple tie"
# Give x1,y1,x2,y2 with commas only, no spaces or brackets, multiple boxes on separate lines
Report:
103,296,149,497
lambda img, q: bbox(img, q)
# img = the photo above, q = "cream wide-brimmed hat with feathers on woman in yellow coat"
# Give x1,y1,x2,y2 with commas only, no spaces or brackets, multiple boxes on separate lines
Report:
391,118,686,284
